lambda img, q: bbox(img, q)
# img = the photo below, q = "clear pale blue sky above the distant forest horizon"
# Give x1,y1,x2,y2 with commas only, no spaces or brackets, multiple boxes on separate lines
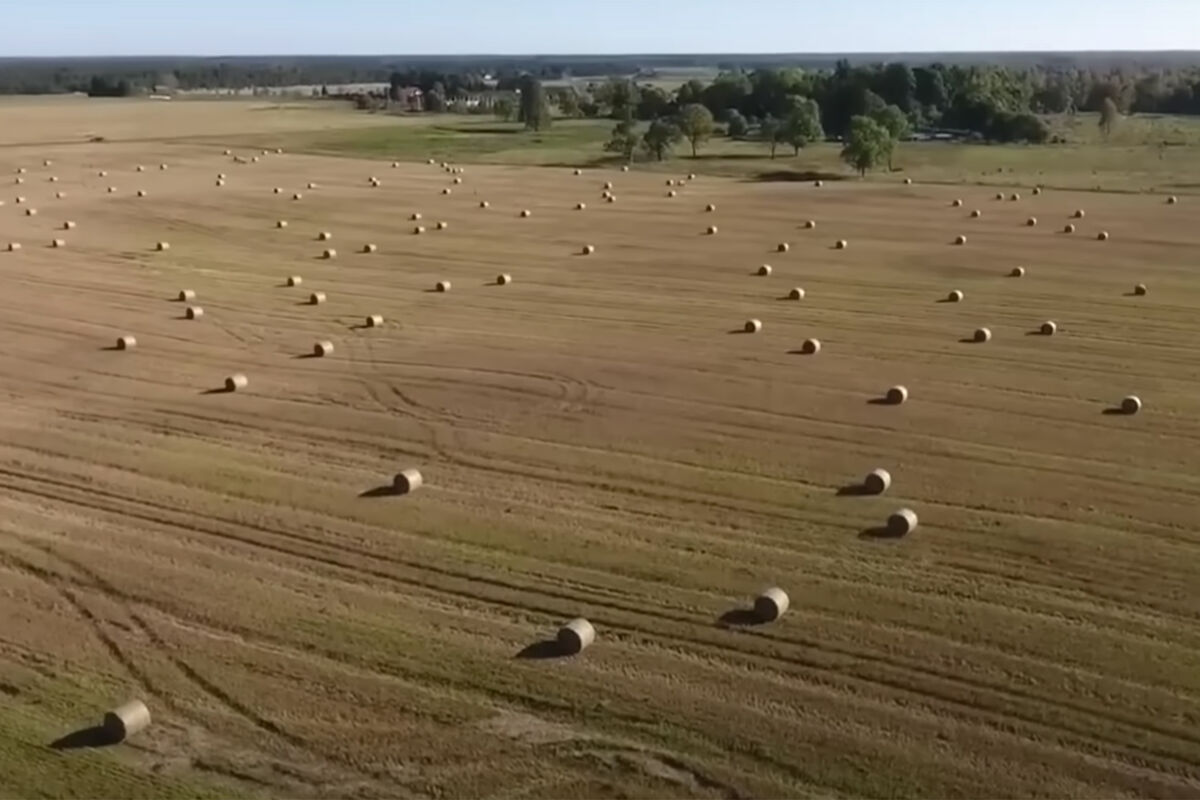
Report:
0,0,1200,56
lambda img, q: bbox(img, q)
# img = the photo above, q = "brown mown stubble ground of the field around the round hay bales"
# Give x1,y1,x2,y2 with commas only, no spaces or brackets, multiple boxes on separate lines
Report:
0,104,1200,798
